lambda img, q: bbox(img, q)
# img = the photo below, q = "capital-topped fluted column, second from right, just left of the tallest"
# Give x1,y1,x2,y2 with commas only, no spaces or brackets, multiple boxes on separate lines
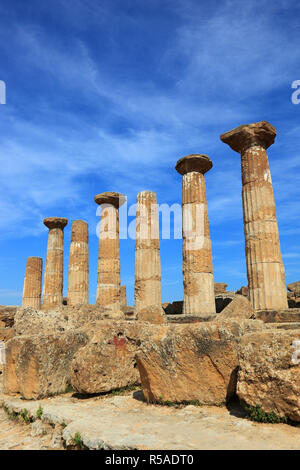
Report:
176,154,216,317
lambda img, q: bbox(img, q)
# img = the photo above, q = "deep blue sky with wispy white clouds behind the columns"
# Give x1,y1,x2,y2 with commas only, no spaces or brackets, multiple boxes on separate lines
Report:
0,0,300,305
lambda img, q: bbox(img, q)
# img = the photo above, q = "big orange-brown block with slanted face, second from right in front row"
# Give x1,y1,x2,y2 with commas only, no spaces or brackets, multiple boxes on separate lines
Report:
136,320,263,405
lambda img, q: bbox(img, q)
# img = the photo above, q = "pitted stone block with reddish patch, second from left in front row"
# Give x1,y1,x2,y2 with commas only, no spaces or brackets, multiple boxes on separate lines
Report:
71,321,168,394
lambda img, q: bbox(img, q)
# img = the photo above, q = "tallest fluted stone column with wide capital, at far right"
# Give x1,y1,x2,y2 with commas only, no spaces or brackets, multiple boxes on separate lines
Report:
221,121,287,310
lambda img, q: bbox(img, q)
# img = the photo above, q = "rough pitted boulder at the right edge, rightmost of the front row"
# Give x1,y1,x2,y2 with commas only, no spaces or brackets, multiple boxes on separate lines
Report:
237,329,300,422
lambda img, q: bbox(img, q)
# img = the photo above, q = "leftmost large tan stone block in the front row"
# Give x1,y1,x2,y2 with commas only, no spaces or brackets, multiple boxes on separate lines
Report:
3,331,88,399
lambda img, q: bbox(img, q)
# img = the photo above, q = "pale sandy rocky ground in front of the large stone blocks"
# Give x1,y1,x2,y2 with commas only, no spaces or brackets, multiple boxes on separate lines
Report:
0,376,300,450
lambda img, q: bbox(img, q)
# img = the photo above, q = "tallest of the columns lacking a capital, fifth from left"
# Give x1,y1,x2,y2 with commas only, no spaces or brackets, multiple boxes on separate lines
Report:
134,191,165,323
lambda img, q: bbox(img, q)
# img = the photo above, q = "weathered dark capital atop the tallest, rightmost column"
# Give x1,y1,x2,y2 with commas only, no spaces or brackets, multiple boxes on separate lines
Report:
220,121,276,153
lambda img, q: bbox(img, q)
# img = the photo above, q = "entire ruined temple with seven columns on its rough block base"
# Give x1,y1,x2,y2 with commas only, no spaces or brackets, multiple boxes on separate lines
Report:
0,121,300,448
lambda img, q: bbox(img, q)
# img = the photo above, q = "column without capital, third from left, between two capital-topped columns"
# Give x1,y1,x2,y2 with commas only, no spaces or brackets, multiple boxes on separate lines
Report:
68,220,89,305
